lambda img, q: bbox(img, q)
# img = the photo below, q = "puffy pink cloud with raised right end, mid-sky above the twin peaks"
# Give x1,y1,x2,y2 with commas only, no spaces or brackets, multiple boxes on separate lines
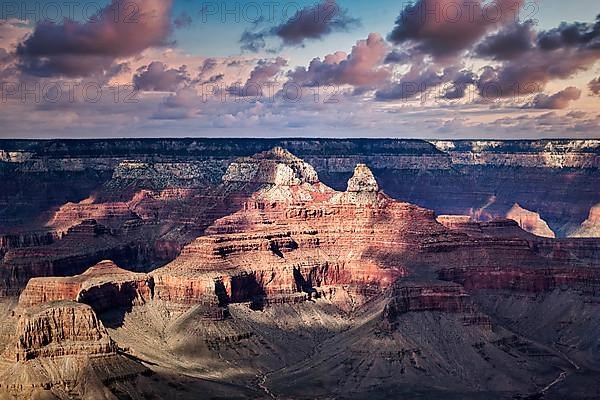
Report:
289,33,391,86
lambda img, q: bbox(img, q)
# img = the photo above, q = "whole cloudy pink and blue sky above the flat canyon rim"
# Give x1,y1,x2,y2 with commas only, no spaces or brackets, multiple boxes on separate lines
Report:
0,0,600,139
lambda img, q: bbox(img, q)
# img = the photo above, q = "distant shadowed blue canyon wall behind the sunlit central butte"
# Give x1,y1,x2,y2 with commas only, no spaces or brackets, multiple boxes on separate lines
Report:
0,139,600,236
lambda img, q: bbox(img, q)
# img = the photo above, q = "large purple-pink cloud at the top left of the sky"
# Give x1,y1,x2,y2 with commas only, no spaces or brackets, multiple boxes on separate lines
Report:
17,0,171,77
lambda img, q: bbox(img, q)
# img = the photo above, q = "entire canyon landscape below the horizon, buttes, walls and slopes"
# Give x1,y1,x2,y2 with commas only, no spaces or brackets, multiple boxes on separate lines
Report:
0,139,600,399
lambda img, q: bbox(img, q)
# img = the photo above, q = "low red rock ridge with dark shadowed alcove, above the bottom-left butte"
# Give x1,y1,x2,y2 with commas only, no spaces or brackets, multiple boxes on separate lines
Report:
19,261,154,312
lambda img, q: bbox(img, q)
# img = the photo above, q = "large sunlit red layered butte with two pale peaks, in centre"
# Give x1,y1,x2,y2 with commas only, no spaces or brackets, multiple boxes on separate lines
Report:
152,151,460,304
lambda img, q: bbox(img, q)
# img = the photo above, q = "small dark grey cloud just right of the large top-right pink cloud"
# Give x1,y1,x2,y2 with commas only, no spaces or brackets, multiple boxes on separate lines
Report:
474,21,536,60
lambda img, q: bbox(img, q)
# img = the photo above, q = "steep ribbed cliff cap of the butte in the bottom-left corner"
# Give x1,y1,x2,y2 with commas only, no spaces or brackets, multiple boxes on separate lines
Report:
14,302,117,361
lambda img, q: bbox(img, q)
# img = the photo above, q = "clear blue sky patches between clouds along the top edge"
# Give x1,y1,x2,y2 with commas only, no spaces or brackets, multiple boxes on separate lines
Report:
169,0,600,63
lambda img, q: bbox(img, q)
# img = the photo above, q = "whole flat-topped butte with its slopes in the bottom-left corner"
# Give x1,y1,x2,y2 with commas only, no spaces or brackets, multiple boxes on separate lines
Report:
0,301,148,400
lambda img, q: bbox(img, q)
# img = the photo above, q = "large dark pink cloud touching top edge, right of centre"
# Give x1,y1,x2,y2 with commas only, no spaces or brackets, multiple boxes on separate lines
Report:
388,0,523,59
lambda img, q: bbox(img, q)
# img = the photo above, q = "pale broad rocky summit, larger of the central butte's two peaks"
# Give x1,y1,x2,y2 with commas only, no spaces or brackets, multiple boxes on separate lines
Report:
223,147,319,186
